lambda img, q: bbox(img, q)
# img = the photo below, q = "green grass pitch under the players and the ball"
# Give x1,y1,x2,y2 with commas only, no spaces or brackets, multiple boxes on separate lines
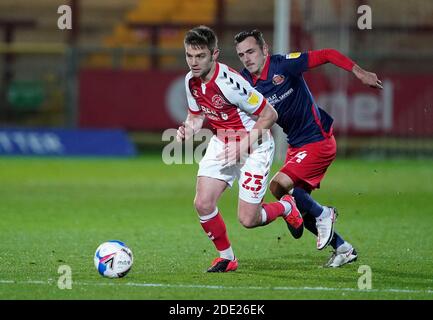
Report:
0,155,433,300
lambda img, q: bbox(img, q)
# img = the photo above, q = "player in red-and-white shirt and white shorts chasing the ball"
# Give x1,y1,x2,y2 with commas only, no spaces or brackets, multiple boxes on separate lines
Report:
177,26,303,272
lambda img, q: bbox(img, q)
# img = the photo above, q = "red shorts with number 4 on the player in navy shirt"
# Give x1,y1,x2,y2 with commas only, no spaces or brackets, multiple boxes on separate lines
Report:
280,135,337,191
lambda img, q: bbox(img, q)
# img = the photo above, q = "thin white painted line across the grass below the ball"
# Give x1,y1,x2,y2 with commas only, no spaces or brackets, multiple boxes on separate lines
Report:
0,280,433,294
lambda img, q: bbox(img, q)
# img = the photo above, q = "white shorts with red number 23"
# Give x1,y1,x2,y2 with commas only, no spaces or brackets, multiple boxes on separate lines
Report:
197,136,275,203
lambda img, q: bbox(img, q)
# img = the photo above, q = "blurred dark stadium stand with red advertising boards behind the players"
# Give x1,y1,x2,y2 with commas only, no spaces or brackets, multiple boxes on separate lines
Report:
0,0,433,157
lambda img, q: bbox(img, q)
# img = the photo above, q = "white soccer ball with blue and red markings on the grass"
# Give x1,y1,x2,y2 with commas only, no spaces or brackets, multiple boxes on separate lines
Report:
94,240,134,278
